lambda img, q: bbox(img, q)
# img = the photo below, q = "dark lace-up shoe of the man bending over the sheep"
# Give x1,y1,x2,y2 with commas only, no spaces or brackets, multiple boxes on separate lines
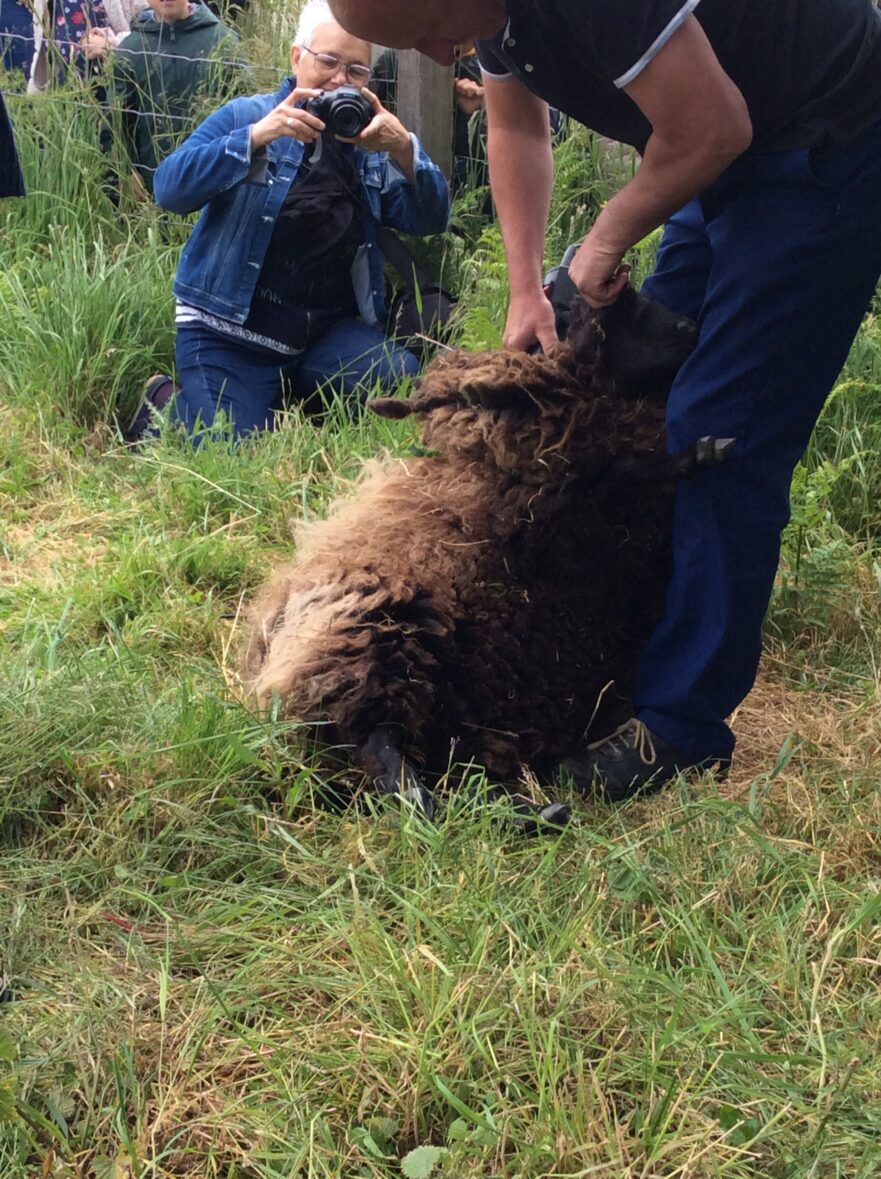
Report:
557,718,729,803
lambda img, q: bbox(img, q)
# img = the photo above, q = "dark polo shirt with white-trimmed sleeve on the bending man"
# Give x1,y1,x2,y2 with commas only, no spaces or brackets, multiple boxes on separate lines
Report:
478,0,881,151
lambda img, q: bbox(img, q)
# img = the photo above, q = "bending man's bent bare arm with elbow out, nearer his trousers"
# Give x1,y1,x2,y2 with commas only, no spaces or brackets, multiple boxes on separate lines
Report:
570,17,752,307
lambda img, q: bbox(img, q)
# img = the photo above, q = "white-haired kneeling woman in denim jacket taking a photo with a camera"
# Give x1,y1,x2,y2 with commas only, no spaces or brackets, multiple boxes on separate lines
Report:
130,2,449,437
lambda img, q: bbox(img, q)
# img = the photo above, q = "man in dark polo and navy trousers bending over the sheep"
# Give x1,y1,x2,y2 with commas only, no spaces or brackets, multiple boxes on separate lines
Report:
333,0,881,797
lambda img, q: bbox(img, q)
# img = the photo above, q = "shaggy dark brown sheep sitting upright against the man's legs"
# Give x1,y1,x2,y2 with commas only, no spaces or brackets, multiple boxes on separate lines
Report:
244,292,729,824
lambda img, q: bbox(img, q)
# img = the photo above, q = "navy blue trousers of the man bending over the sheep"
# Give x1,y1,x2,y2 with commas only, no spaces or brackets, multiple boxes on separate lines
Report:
635,124,881,759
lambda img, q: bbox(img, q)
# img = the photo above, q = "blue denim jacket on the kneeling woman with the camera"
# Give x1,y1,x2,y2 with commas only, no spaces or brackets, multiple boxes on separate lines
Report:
153,78,449,323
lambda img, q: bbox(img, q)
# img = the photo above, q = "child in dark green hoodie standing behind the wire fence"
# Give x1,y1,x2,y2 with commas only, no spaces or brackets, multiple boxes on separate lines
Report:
111,0,238,192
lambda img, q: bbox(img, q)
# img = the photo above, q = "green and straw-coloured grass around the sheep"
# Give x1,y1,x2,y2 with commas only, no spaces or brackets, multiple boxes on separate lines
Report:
0,59,881,1179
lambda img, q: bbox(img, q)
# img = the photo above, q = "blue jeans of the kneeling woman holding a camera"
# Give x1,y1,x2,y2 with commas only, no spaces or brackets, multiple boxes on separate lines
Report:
172,320,419,439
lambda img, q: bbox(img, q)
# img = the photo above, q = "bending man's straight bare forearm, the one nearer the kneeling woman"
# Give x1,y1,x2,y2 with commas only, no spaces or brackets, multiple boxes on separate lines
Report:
484,75,557,351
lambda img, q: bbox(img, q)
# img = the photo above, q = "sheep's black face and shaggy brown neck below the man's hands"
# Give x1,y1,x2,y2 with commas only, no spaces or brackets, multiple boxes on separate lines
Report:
369,288,697,485
